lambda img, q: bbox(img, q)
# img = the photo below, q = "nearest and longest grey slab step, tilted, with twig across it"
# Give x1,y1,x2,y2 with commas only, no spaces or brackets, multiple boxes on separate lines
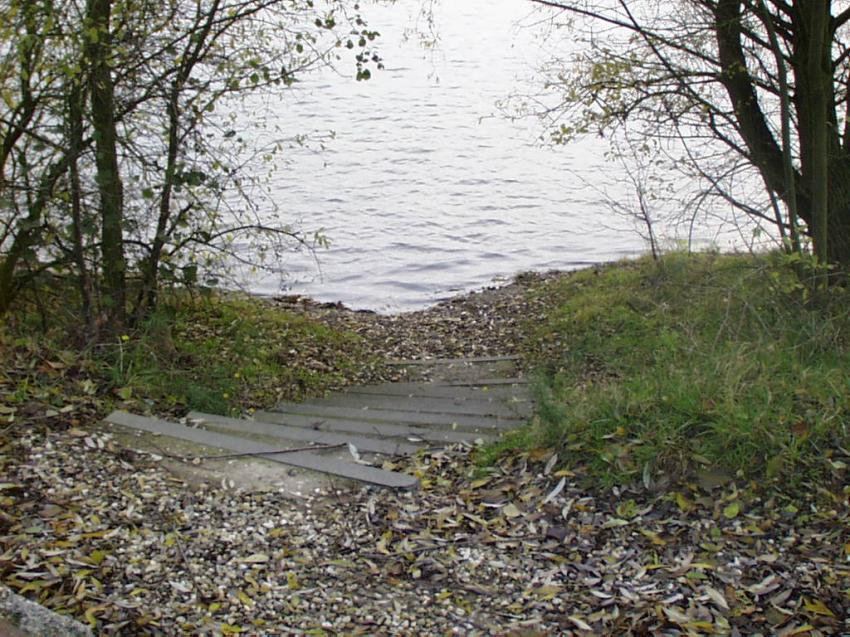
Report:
104,411,419,489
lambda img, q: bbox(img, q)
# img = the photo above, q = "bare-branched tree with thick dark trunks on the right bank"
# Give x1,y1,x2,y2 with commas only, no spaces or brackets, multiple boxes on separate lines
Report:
533,0,850,268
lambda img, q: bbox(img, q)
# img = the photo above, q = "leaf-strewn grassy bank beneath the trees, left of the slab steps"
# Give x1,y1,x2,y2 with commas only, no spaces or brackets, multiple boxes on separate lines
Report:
0,294,377,422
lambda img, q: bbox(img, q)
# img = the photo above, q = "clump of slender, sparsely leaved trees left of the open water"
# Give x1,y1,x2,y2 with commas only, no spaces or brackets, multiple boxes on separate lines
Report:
0,0,379,332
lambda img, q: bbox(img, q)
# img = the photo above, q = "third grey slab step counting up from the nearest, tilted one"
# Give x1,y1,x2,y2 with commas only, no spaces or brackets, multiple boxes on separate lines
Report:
254,411,495,444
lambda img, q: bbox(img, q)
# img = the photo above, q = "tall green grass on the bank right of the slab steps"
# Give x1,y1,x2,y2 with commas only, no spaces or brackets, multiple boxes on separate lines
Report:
510,254,850,484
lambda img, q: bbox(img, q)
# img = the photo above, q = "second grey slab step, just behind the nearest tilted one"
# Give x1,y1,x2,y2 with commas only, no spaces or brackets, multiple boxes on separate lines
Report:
188,411,422,456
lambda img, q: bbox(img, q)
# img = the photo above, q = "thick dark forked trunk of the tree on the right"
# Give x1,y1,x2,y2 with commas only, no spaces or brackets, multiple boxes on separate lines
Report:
714,0,850,267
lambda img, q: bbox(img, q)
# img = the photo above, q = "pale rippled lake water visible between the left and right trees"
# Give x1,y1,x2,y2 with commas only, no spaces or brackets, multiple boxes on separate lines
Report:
232,0,744,312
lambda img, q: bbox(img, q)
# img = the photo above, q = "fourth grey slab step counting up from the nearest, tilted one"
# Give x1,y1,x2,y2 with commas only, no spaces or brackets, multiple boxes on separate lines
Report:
271,397,525,429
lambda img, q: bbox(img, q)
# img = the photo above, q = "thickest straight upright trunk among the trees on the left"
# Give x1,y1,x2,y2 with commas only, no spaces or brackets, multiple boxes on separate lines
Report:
85,0,127,331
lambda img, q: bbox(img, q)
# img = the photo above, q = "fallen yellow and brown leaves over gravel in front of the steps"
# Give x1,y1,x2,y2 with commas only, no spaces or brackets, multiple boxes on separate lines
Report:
0,422,850,636
